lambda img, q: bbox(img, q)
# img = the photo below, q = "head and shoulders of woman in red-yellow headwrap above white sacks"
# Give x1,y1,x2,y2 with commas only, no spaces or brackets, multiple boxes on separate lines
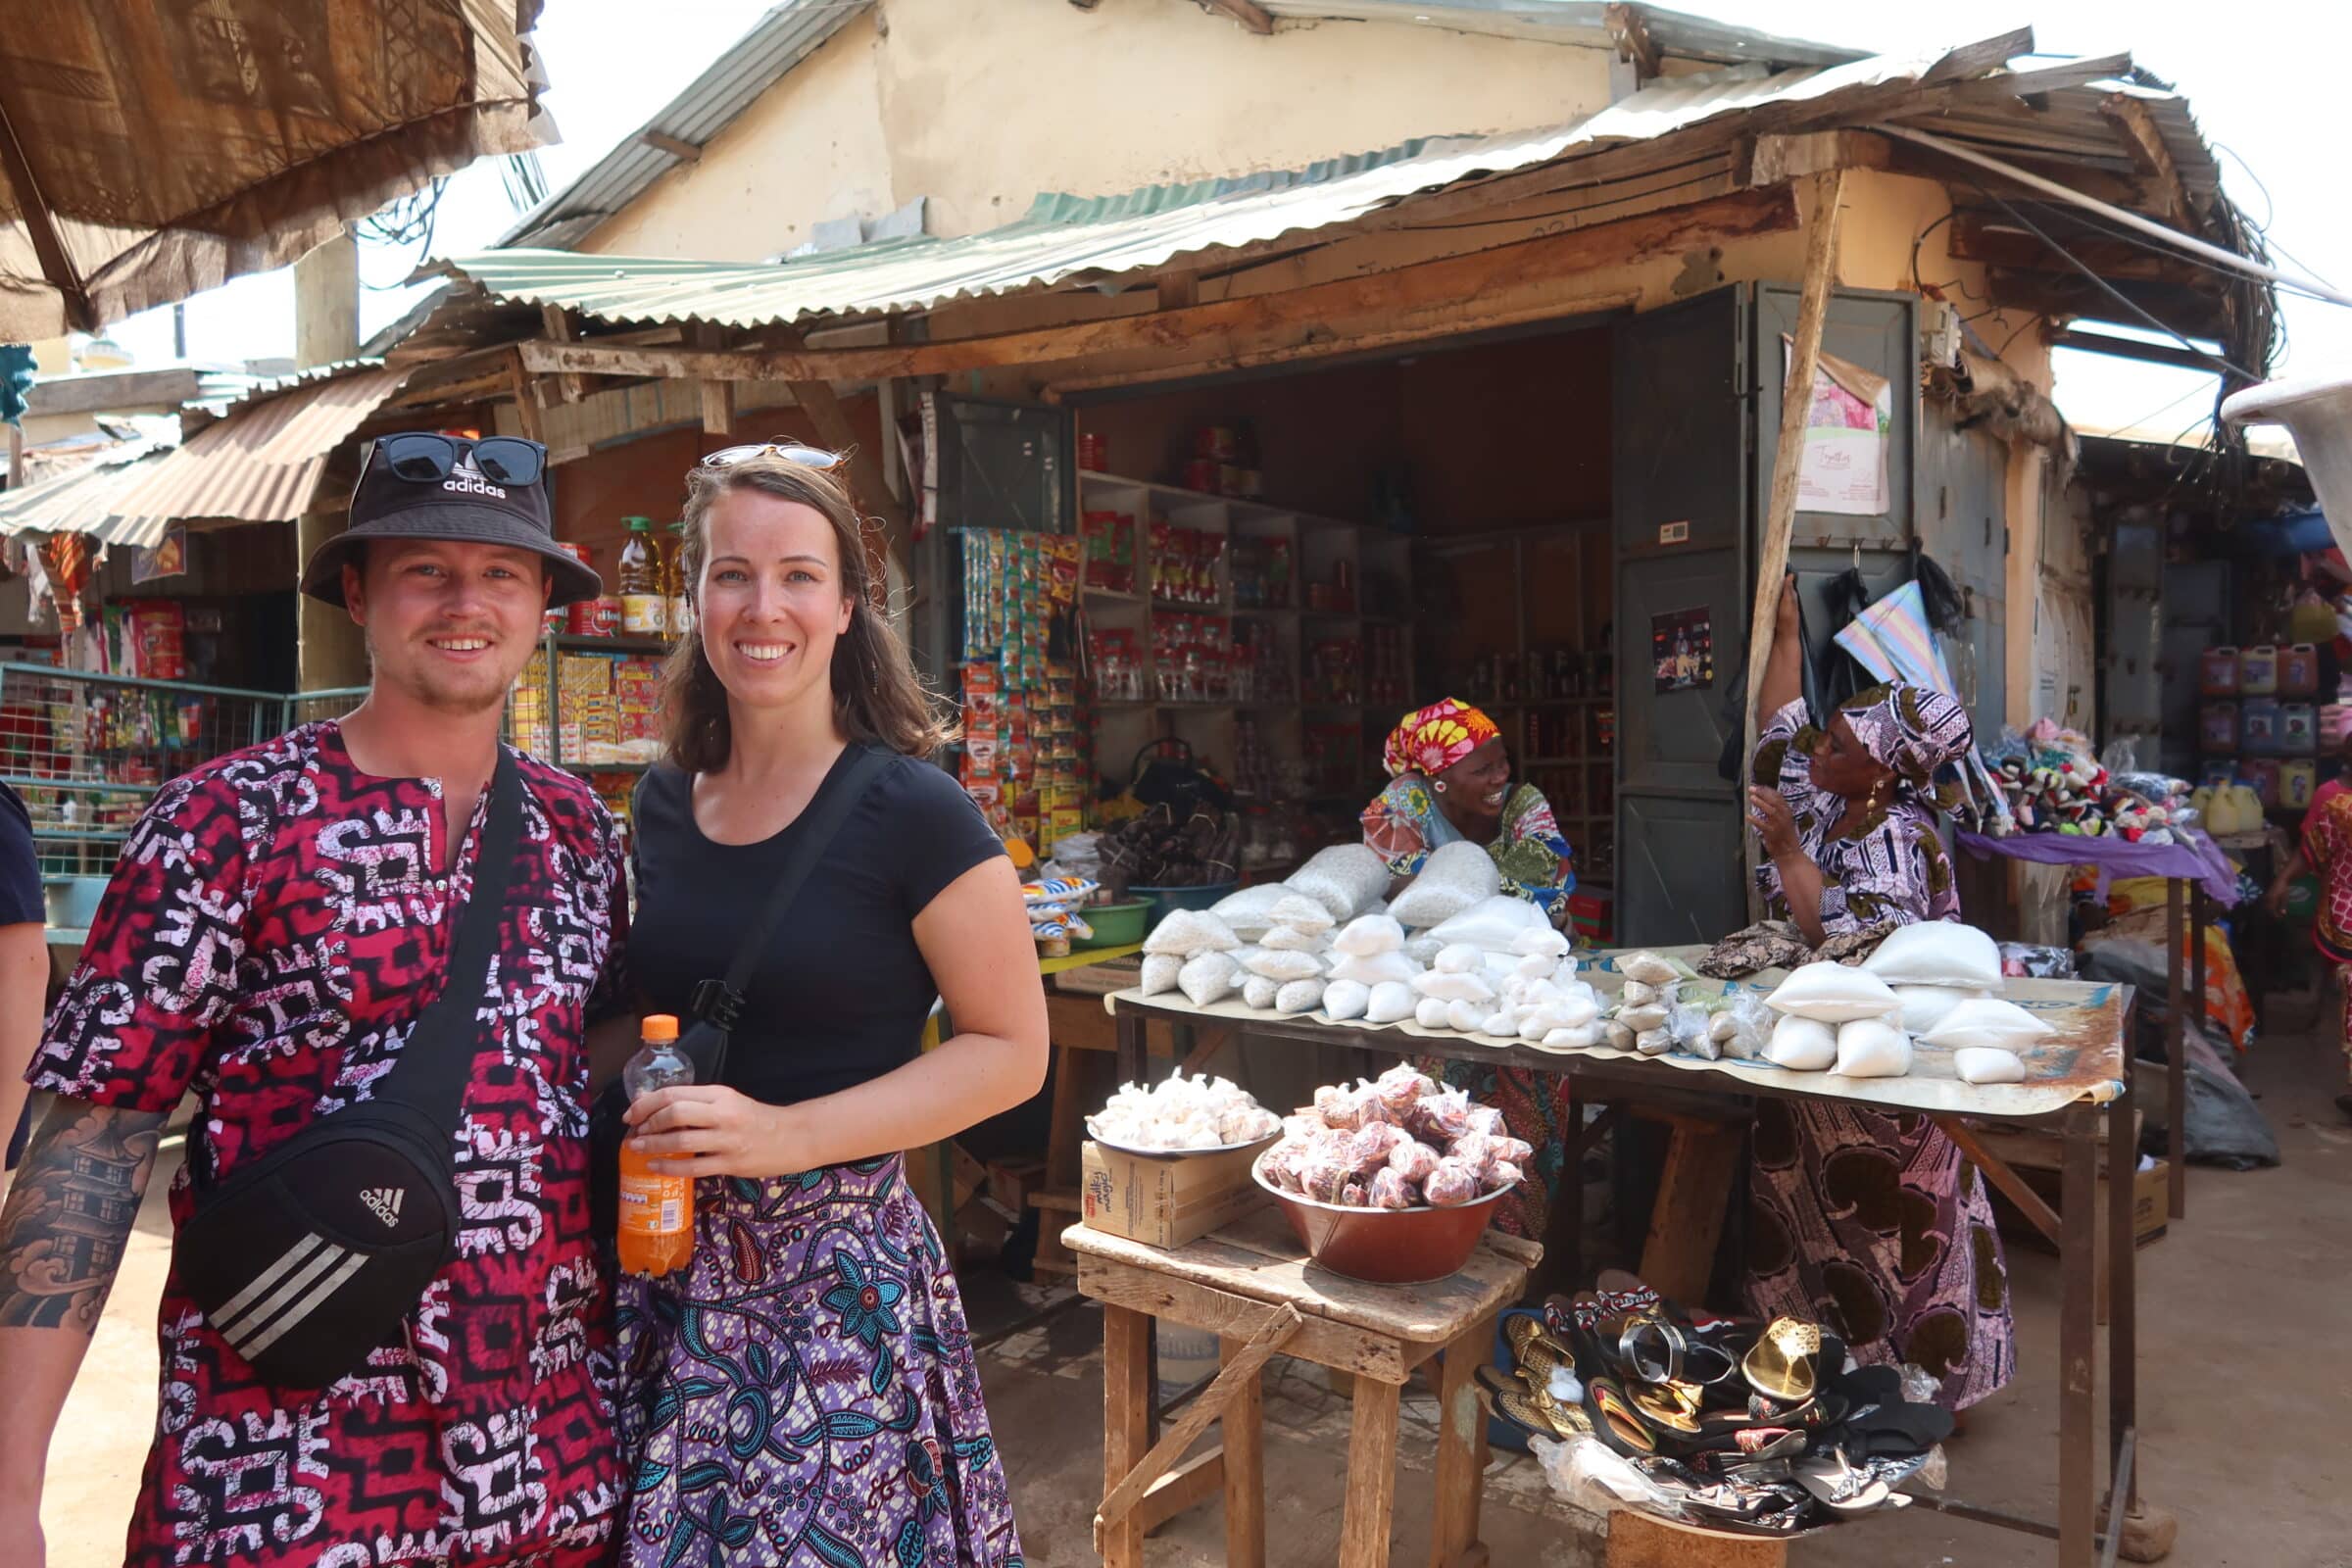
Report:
1364,698,1576,926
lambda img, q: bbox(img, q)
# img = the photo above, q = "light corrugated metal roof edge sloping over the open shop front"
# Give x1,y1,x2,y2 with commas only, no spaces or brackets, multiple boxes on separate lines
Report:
447,41,2117,326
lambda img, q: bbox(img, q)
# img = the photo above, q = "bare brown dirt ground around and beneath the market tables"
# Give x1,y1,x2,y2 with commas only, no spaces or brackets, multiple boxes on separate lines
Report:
42,1018,2352,1568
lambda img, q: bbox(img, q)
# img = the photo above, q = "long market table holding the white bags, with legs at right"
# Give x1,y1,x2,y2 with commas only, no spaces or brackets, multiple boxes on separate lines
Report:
1105,955,2140,1568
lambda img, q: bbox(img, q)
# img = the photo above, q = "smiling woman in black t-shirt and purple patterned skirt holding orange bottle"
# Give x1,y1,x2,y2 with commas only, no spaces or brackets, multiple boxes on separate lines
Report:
616,447,1047,1568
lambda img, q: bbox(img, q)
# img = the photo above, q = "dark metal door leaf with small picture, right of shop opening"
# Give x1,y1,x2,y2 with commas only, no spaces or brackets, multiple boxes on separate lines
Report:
1611,287,1752,945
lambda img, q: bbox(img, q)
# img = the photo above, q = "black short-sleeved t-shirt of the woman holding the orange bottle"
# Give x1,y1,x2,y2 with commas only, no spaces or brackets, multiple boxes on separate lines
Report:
628,753,1004,1104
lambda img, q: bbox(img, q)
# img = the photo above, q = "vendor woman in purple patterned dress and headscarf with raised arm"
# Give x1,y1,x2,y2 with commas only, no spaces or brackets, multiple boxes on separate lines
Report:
1745,581,2016,1410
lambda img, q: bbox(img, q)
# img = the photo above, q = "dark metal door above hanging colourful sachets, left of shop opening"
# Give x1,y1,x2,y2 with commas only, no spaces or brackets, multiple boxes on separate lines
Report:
912,393,1077,689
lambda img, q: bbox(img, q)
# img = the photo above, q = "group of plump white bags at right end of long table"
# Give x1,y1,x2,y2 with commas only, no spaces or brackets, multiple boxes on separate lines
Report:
1764,919,2053,1084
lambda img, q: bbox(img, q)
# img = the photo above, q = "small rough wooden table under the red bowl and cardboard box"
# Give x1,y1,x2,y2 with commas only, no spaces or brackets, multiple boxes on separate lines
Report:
1063,1208,1543,1568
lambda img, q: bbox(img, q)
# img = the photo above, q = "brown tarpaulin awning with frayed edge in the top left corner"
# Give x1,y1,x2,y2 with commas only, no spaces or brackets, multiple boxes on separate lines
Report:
0,0,553,341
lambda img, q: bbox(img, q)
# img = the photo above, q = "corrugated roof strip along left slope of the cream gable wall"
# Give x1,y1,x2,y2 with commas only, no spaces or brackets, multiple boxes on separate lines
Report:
499,0,872,247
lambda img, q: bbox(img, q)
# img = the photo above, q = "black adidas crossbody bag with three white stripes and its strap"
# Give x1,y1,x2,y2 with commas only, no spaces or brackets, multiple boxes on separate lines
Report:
172,748,522,1390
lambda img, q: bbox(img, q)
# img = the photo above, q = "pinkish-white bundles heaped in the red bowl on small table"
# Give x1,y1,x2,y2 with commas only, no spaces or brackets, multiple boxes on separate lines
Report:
1258,1062,1536,1208
